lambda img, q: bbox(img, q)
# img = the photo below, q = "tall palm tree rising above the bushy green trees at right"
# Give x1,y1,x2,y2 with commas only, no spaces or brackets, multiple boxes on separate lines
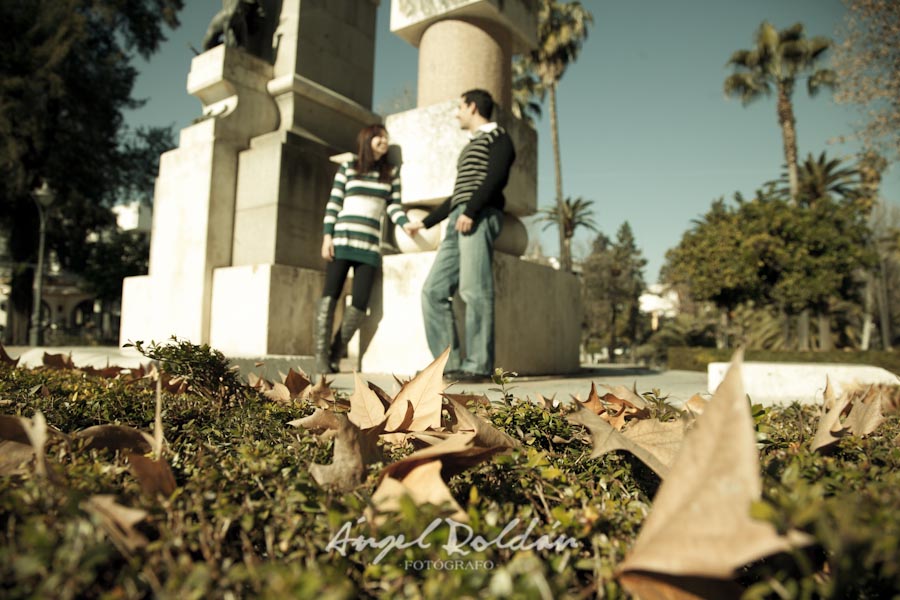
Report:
725,21,837,201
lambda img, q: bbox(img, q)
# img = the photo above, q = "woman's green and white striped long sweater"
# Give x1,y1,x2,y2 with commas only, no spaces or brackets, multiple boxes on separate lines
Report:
324,161,409,267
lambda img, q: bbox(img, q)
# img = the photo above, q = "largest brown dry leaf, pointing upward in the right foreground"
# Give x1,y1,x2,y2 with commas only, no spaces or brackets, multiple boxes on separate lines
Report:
618,352,808,597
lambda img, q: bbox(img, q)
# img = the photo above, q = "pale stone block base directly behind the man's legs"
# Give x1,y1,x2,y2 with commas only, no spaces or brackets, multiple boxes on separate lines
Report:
357,252,582,375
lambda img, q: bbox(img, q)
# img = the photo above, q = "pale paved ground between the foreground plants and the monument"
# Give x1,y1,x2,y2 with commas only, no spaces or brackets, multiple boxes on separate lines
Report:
6,346,707,404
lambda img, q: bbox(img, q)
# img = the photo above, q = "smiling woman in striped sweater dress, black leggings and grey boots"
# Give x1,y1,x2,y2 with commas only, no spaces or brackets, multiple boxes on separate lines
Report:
314,125,415,373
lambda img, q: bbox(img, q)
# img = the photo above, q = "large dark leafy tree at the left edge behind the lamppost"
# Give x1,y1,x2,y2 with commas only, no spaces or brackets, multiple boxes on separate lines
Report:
0,0,183,343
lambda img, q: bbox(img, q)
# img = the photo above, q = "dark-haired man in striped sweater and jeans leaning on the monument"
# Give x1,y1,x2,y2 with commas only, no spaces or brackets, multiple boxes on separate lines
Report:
406,90,516,383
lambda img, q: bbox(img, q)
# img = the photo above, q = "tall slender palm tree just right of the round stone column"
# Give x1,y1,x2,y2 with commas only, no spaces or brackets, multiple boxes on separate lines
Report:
524,0,594,271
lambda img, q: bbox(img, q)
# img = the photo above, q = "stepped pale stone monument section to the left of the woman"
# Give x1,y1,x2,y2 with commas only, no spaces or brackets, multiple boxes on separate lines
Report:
120,0,380,356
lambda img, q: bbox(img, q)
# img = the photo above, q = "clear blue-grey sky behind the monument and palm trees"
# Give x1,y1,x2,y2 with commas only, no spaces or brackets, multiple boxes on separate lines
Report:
127,0,900,283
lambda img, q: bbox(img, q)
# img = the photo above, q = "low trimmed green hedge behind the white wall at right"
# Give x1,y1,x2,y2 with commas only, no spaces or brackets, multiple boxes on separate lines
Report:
667,346,900,374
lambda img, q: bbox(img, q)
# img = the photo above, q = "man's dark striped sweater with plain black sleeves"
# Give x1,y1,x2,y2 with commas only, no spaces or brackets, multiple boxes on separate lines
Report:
422,123,516,227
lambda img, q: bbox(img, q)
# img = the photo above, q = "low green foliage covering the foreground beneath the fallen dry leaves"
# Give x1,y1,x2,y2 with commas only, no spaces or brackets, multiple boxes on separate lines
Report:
0,345,900,599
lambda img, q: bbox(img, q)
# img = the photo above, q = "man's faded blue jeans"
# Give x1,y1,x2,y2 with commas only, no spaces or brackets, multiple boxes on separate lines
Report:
422,204,503,374
